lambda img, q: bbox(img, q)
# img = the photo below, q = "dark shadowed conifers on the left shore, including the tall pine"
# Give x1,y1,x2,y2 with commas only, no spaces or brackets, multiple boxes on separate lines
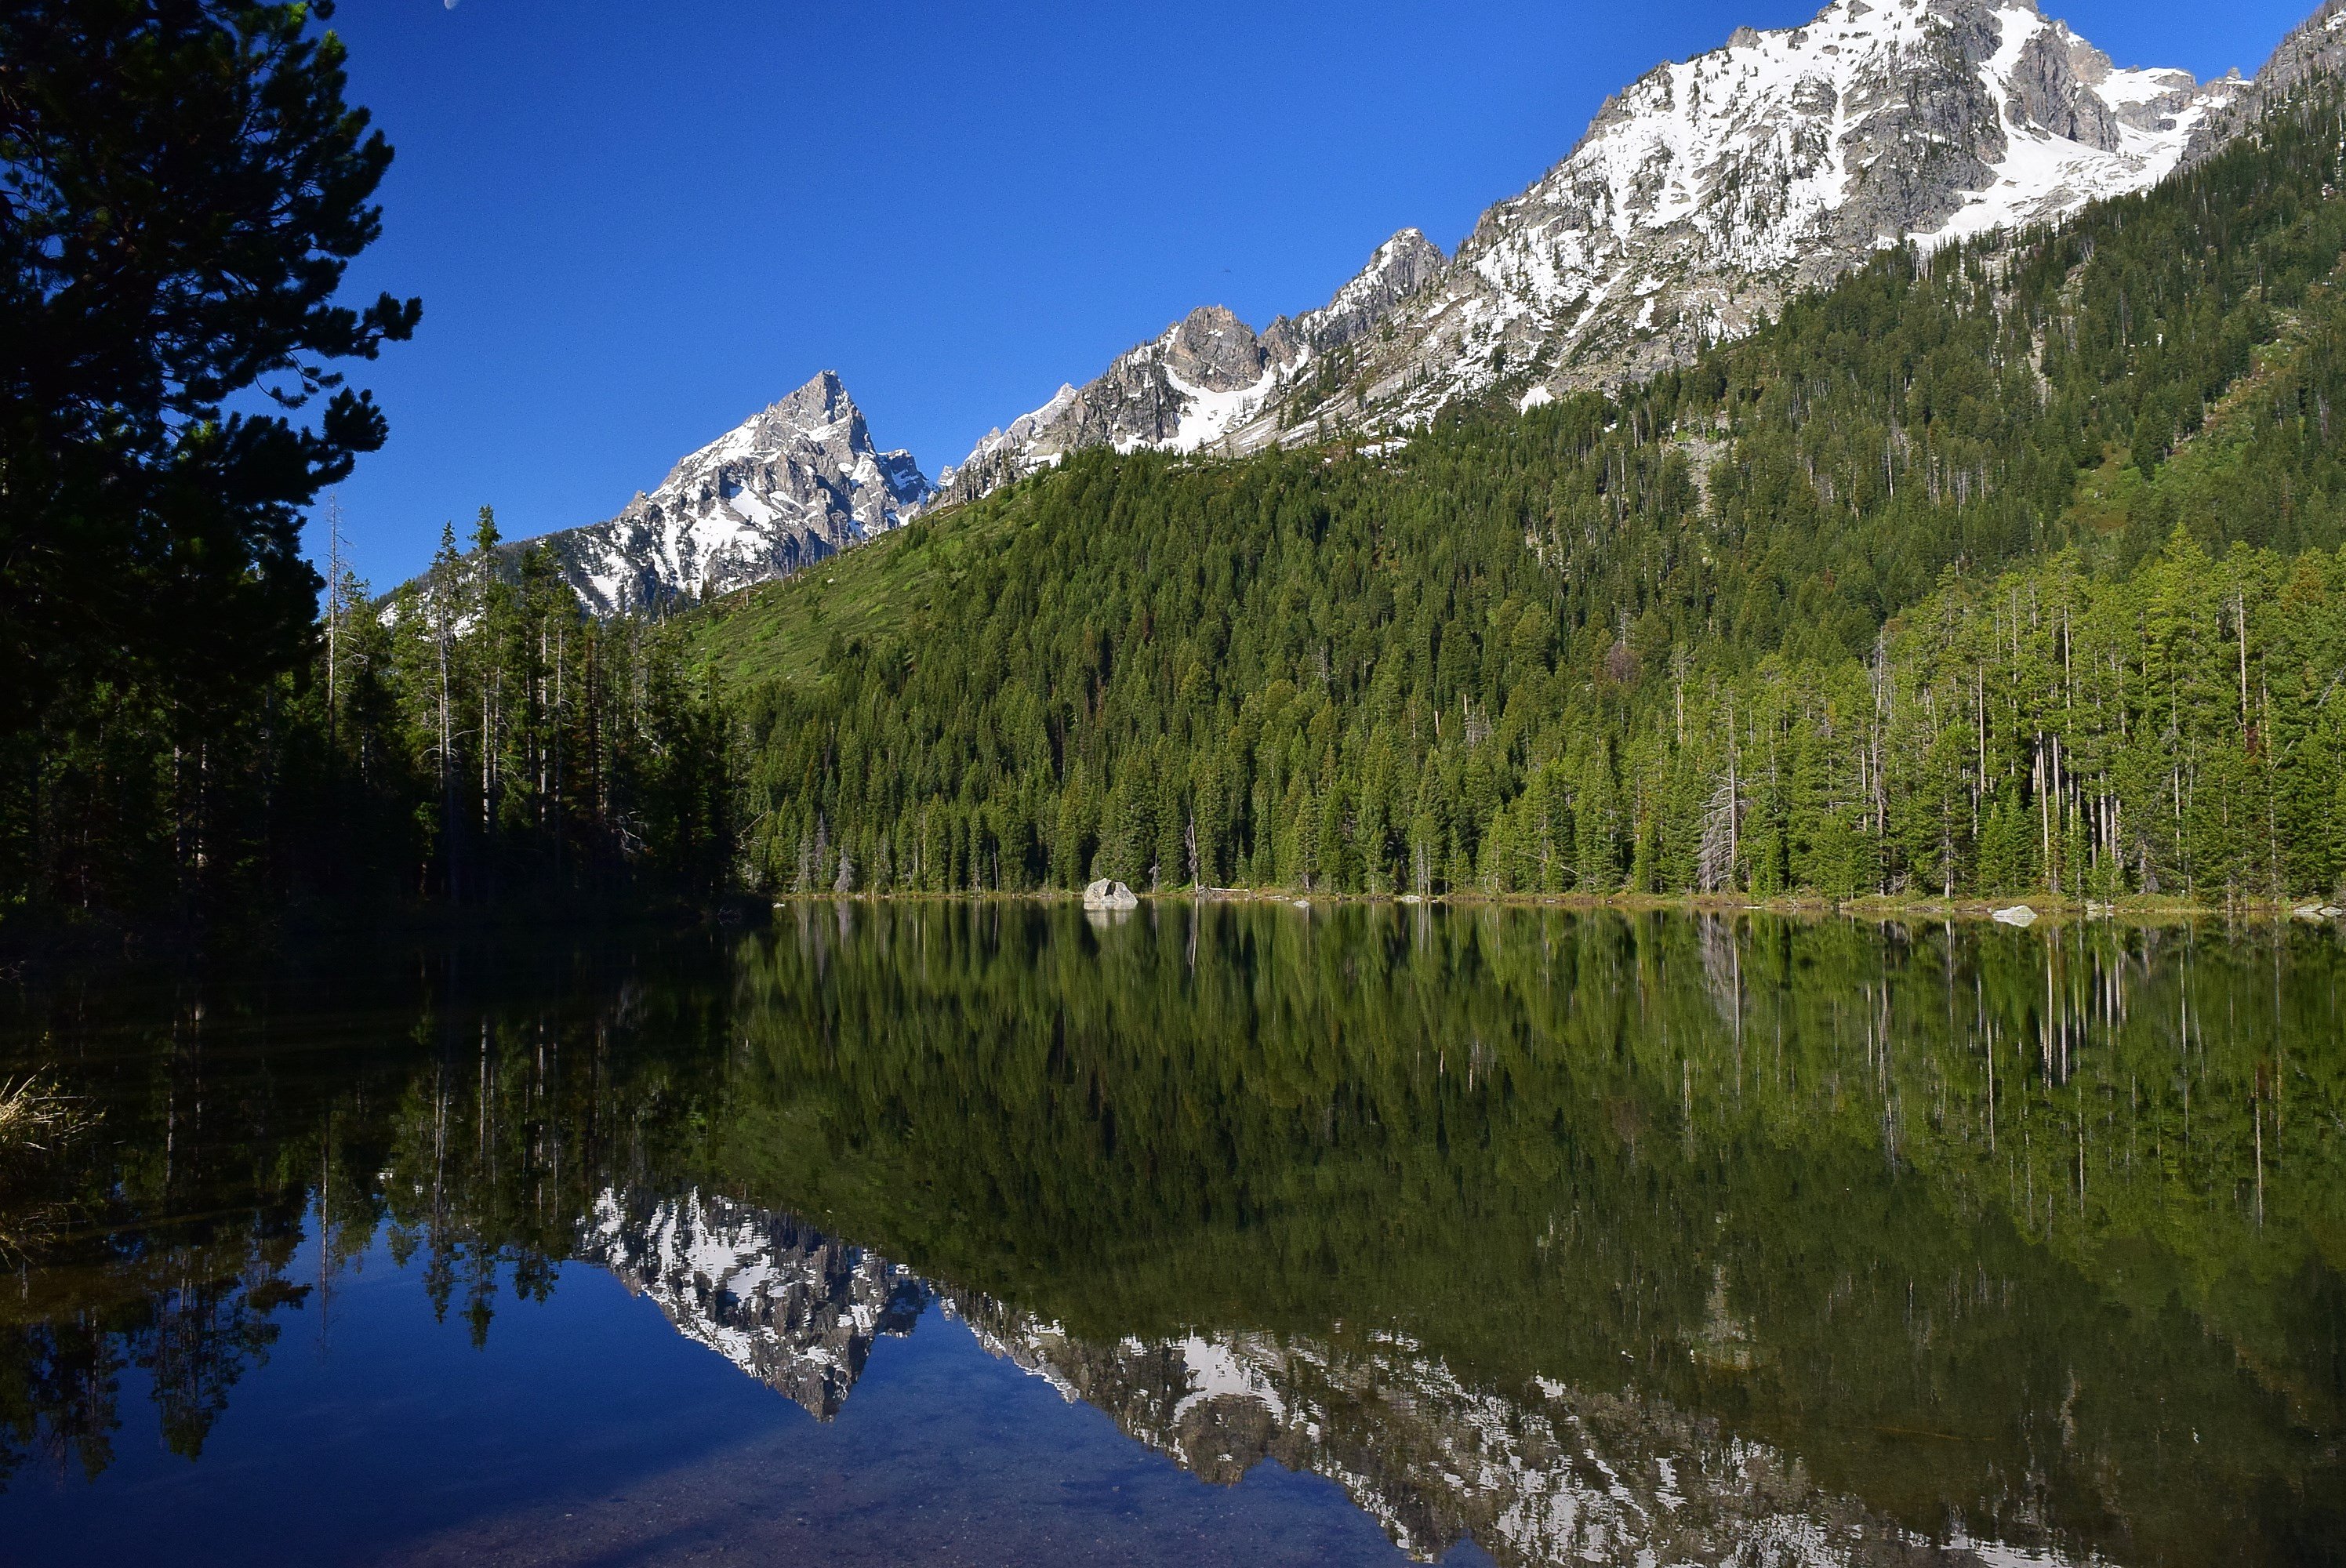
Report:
0,0,732,946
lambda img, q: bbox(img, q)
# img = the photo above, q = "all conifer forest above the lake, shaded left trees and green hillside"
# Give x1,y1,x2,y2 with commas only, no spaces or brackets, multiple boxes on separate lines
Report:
18,7,2346,930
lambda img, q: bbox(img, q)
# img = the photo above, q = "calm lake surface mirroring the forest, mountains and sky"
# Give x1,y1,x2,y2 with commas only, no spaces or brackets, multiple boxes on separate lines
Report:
0,904,2346,1566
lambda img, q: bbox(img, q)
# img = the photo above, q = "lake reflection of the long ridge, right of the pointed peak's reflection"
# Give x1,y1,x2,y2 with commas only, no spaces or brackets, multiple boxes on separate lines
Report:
962,1301,2065,1568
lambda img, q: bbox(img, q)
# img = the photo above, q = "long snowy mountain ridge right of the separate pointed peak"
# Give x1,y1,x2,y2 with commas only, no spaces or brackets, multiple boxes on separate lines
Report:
950,0,2233,498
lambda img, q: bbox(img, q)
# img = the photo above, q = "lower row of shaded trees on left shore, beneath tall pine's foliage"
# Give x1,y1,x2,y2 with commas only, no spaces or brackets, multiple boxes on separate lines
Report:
0,510,732,932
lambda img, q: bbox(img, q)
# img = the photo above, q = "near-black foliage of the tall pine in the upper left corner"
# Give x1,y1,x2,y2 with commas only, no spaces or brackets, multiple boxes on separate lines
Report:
0,0,420,732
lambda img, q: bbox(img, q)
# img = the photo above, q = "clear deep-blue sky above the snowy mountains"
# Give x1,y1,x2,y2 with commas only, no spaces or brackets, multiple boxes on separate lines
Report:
312,0,2315,587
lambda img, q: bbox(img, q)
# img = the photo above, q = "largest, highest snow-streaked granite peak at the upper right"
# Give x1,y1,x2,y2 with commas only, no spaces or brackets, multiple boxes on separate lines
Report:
1358,0,2238,420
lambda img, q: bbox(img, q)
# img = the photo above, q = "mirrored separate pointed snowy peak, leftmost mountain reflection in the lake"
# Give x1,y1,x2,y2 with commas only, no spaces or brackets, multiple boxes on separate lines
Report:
577,1192,929,1420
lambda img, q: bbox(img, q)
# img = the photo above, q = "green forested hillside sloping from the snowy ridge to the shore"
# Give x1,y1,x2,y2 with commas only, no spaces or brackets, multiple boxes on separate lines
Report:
699,85,2346,899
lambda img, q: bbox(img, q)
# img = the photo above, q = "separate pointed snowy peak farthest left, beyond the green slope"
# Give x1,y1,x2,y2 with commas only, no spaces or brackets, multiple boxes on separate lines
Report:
542,371,934,615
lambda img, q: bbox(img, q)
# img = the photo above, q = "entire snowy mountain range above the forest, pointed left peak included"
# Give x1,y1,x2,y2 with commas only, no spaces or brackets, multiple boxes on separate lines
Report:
499,0,2346,615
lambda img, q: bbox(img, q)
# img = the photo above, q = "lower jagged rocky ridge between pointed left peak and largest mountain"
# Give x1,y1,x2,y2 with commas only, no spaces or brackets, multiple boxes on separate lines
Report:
939,227,1443,500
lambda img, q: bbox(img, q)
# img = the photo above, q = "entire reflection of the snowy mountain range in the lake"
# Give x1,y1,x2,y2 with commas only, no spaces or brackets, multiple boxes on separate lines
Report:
579,1192,2092,1568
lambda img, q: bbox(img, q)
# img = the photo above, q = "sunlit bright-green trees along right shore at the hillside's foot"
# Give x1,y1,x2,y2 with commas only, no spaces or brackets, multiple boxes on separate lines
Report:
1482,531,2346,904
